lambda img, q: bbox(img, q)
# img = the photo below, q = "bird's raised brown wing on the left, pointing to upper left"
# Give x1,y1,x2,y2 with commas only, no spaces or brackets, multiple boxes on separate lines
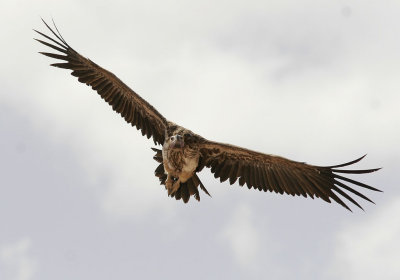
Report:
35,19,167,145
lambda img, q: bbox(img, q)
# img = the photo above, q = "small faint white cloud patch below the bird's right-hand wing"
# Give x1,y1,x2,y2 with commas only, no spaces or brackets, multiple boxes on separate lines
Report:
220,204,261,269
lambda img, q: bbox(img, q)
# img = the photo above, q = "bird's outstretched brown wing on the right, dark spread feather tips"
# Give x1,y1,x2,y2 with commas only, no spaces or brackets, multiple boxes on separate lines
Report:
198,140,380,211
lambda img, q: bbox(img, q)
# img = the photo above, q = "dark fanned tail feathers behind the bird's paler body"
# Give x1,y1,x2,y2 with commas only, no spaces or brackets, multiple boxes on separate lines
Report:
151,148,211,203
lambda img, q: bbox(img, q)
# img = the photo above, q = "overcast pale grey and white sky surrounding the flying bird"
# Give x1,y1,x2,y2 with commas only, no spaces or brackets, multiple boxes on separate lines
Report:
0,0,400,280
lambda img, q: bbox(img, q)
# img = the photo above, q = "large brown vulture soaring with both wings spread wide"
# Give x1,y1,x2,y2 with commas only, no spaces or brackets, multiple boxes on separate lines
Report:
34,19,380,211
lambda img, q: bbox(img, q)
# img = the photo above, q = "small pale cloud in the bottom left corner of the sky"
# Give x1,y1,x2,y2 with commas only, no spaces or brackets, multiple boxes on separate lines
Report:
0,238,38,280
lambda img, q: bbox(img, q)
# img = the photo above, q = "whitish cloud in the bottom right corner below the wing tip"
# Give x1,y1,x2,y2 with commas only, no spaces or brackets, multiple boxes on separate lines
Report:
330,198,400,280
